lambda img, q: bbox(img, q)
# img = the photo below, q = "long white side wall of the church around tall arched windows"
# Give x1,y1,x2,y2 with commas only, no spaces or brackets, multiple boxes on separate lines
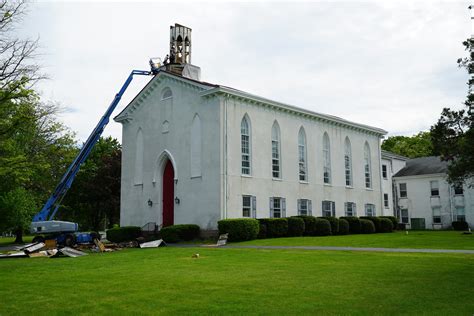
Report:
226,99,382,218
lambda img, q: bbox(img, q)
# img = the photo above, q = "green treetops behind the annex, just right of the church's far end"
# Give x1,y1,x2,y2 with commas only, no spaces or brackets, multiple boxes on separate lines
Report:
382,132,434,158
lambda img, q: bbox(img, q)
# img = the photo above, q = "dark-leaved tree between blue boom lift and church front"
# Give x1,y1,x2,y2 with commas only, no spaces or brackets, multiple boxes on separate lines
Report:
59,137,122,230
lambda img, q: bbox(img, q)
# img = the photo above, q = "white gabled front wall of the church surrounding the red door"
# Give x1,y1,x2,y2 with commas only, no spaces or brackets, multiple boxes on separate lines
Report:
120,74,221,229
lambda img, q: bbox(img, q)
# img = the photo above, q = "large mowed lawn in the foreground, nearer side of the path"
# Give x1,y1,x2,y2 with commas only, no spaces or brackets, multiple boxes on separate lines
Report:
0,247,474,315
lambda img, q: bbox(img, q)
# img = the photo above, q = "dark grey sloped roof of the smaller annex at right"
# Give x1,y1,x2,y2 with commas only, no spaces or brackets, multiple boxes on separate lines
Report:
393,156,448,177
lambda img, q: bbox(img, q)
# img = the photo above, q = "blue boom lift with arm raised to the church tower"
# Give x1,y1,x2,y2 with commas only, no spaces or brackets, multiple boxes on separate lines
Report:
30,59,161,246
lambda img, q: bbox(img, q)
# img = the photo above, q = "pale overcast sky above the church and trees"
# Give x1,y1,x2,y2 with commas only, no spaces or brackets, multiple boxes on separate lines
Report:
21,1,471,140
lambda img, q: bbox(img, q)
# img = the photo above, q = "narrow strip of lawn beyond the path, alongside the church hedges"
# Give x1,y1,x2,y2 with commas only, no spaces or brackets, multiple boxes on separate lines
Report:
233,231,474,249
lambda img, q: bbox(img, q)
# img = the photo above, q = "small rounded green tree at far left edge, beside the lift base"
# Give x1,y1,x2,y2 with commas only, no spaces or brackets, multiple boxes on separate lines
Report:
0,187,37,243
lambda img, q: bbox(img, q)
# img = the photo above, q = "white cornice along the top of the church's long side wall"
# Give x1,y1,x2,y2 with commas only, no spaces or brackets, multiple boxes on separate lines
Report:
201,86,387,137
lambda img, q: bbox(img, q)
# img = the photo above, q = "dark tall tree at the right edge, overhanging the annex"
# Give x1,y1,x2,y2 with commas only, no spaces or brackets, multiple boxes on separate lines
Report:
431,38,474,185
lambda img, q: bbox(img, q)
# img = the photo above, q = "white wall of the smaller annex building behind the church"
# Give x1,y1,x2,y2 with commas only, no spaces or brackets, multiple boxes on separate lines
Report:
394,174,474,229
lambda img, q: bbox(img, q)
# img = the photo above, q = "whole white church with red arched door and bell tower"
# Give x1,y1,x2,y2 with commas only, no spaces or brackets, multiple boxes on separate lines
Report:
115,25,393,230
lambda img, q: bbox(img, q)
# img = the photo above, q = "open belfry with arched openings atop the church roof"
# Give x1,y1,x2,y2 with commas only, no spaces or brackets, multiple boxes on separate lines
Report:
169,23,192,64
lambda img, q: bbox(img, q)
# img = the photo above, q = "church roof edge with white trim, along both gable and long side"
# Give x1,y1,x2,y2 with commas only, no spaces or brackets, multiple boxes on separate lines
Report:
114,70,387,136
